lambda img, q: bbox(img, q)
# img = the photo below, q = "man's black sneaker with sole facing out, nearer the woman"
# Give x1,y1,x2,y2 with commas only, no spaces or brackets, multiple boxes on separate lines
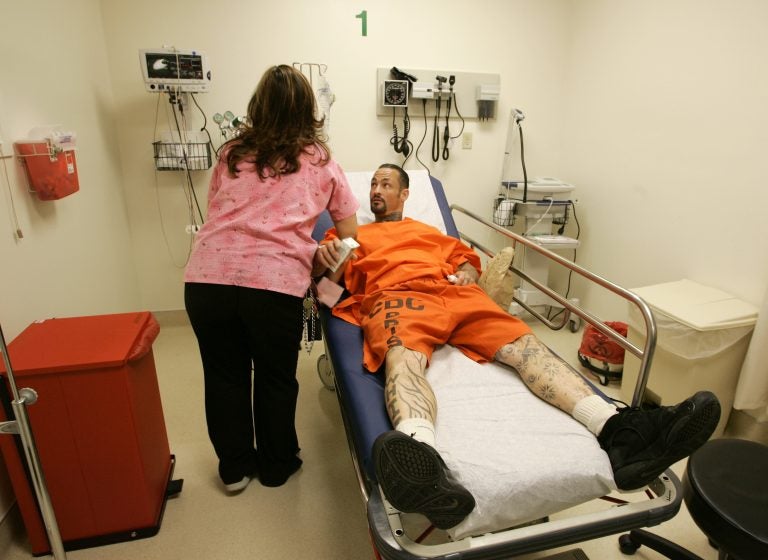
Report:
373,431,475,529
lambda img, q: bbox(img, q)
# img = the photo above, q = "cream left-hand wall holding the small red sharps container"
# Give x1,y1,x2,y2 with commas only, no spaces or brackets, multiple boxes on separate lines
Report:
0,0,141,519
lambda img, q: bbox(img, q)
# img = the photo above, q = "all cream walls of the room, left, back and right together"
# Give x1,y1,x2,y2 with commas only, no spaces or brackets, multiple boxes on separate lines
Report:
0,0,768,536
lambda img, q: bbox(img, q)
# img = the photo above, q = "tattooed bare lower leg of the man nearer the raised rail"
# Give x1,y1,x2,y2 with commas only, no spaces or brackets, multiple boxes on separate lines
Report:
495,334,594,414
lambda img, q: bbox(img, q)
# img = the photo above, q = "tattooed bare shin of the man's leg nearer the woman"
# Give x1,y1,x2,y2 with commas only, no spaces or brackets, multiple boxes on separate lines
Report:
384,346,437,426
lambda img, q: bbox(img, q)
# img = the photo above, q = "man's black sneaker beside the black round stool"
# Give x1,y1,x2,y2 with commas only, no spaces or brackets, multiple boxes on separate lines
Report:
597,391,720,490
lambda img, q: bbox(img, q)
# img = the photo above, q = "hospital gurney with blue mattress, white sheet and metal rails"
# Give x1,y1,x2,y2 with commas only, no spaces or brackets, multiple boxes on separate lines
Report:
314,171,682,560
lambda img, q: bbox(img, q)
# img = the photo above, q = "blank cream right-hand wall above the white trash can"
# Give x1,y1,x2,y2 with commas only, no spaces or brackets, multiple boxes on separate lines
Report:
561,0,768,320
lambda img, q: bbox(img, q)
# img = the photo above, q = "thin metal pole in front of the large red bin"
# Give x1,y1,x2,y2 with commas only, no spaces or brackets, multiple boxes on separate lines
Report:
0,325,67,560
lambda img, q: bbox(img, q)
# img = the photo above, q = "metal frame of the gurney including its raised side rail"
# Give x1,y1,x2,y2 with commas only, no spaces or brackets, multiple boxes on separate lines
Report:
321,177,682,560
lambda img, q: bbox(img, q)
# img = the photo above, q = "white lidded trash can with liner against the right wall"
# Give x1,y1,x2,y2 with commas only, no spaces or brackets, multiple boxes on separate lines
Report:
621,280,758,437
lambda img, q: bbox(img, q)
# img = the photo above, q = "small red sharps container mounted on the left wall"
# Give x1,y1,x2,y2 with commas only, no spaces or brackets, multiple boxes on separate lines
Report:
15,142,80,200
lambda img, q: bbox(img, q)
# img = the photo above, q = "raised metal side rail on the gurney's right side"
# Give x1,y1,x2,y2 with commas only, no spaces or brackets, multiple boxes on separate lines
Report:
451,204,657,406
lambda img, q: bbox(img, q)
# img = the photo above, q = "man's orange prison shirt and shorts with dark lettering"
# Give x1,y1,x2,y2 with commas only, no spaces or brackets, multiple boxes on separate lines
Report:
326,218,531,371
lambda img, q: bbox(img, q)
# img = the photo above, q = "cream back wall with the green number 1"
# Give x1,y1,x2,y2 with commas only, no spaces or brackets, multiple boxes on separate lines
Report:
103,0,568,309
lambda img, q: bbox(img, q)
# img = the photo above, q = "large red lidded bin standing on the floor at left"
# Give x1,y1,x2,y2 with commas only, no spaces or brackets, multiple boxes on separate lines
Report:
0,312,180,555
